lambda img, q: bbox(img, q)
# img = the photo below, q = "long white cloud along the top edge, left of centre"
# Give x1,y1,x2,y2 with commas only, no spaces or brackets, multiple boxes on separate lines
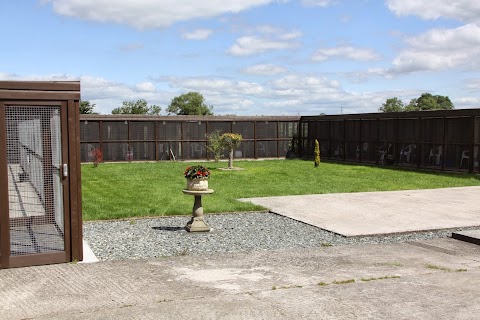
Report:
43,0,273,29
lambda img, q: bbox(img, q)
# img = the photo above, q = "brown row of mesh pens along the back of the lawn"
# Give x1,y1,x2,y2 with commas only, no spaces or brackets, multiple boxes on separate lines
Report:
81,115,300,162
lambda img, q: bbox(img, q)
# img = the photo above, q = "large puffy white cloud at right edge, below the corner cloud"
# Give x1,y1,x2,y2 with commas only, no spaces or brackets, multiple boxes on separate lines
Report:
391,24,480,73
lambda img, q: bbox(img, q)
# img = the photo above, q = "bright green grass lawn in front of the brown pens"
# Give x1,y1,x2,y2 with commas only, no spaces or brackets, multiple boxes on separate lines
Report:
82,160,480,220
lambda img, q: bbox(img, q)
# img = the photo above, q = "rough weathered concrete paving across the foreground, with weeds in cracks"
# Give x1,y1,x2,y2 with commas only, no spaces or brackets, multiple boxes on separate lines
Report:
0,238,480,320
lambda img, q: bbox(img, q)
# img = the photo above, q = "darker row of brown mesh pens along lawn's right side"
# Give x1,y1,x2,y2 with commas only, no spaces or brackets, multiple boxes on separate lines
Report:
299,109,480,172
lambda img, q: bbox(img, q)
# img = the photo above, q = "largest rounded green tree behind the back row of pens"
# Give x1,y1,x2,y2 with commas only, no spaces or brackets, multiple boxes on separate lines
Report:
167,92,213,116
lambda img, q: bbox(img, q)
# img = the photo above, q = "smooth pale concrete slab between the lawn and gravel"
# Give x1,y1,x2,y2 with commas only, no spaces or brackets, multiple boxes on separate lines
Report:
239,187,480,237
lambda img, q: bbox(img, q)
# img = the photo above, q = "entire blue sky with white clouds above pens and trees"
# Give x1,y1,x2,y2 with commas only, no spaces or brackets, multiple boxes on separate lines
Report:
0,0,480,115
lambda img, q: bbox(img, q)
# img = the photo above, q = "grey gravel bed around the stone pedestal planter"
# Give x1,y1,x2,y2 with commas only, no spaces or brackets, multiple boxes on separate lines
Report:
83,212,478,260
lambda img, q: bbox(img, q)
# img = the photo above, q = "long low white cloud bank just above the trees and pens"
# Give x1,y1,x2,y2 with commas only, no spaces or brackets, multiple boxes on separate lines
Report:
0,73,446,115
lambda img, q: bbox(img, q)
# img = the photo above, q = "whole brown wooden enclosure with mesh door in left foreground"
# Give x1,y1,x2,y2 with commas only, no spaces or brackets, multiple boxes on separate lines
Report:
0,81,82,268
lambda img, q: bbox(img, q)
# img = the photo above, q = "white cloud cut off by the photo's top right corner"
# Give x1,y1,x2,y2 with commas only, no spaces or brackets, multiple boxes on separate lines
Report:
387,0,480,22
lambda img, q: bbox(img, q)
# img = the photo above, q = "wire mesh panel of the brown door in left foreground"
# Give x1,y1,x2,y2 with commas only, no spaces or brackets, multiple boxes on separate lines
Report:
5,106,64,256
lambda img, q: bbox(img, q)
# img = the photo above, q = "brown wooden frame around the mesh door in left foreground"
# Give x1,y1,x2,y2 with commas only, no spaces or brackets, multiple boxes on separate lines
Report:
0,81,83,268
